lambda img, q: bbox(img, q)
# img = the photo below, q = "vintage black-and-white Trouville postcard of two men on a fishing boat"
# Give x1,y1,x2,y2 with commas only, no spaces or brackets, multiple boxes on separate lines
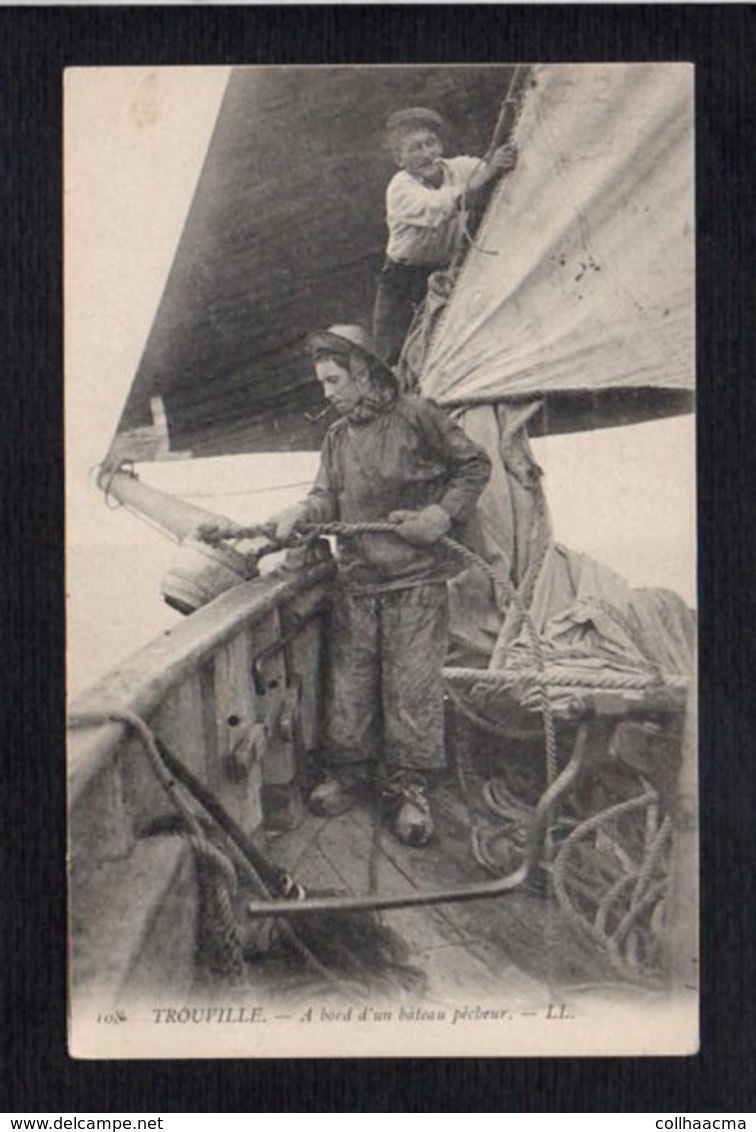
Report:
65,62,698,1058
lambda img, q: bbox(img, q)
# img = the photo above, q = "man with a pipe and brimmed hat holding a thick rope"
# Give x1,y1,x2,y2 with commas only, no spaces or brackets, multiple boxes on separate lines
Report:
262,326,490,846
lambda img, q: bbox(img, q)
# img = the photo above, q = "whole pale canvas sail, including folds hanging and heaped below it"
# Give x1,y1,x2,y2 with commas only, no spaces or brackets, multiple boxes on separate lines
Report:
420,65,695,688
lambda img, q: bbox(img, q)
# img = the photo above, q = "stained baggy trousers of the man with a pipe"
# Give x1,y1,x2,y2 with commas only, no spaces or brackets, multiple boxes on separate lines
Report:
327,582,448,777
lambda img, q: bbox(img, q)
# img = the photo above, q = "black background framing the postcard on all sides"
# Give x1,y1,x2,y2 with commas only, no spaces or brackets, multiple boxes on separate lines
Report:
0,5,756,1113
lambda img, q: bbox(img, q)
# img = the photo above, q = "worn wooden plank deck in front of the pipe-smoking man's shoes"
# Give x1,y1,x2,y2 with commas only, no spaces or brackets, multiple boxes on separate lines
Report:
243,779,612,1009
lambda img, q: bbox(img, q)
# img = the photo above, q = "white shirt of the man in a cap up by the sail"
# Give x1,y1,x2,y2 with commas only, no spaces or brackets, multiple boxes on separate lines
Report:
386,156,482,267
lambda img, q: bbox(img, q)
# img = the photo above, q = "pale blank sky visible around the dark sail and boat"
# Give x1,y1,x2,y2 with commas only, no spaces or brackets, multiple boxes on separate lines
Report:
65,67,696,693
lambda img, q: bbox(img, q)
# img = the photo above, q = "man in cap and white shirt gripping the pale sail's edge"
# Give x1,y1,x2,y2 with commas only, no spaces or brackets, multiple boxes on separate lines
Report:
372,106,517,365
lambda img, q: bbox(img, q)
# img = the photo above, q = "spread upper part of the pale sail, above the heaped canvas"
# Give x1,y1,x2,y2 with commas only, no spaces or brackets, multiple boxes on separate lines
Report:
421,63,695,432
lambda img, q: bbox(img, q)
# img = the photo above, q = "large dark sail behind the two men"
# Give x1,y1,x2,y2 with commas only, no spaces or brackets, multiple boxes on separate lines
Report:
110,66,512,462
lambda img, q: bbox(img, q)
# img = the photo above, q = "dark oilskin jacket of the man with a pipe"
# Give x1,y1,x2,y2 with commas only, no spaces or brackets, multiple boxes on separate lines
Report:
304,395,491,593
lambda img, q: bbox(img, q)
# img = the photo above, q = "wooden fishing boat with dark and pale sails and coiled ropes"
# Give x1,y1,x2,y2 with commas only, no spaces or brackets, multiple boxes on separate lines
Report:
69,65,697,1056
